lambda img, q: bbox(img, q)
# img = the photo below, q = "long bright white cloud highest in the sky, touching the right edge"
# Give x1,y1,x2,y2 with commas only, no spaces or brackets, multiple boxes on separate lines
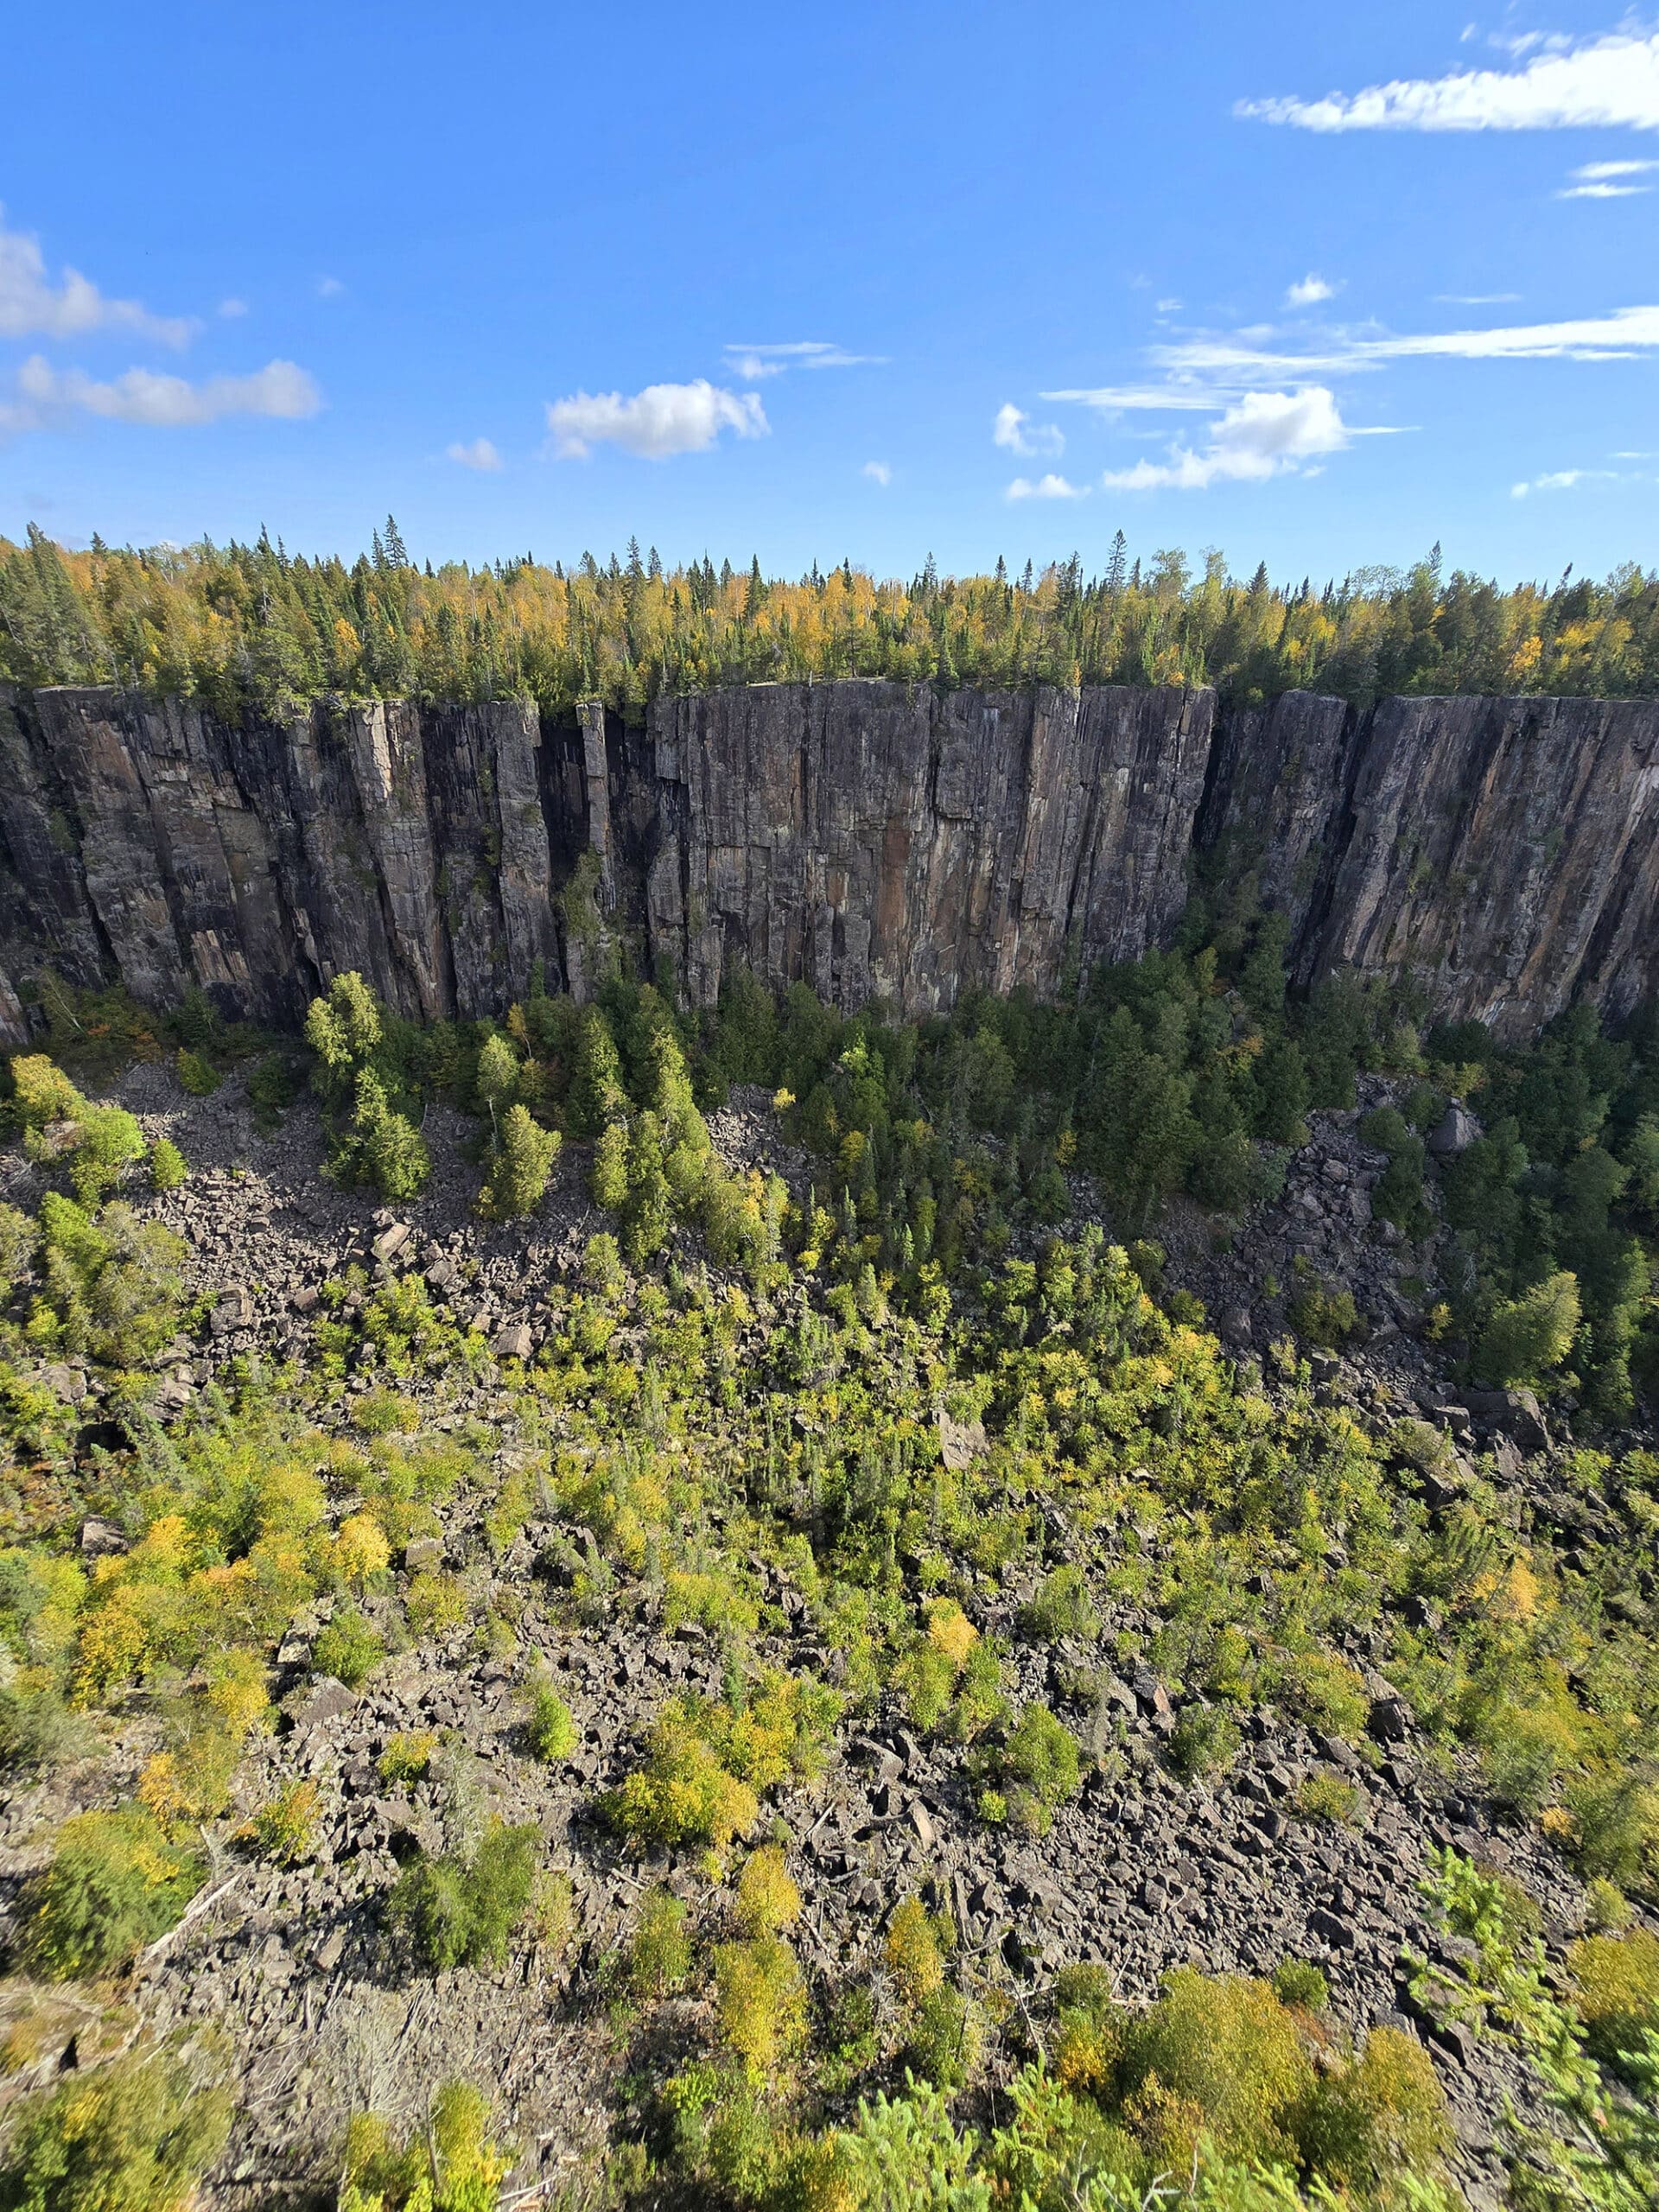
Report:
1234,31,1659,130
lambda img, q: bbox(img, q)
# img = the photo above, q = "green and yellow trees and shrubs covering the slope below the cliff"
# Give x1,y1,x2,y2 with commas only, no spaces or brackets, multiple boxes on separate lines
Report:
0,925,1659,2212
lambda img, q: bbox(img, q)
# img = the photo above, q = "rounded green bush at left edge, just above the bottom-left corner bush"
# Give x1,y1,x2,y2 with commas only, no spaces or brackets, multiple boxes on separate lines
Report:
24,1805,204,1980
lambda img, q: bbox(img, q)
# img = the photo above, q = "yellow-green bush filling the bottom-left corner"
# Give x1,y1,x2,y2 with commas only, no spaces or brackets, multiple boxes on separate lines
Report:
0,2050,232,2212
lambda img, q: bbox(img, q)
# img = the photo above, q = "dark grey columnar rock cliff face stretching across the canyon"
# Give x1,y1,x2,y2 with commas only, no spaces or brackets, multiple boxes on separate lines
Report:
0,681,1659,1039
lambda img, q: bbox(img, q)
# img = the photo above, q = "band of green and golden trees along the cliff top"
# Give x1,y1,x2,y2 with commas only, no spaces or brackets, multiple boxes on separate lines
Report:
0,518,1659,721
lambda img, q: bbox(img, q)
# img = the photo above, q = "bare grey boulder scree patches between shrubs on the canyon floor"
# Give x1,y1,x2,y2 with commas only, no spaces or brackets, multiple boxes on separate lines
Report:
0,1066,1637,2208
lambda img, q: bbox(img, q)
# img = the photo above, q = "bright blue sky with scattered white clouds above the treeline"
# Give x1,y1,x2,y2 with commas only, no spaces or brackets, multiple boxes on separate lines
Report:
0,0,1659,584
